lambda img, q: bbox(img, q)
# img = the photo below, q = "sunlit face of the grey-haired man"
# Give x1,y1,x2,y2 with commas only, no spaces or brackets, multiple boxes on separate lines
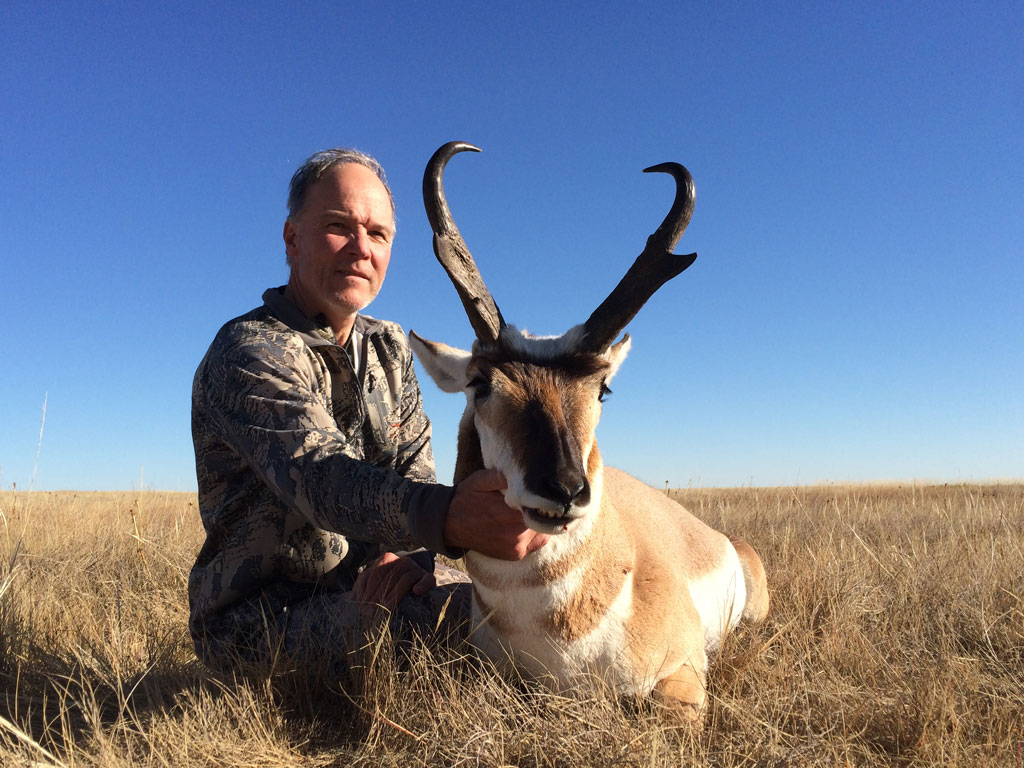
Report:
284,163,394,326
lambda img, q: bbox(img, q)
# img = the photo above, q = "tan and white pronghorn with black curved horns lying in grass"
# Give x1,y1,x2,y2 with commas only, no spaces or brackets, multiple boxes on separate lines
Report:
411,141,768,720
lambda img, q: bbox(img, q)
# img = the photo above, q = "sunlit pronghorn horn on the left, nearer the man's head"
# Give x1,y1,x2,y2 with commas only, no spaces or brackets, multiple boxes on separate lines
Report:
423,141,505,344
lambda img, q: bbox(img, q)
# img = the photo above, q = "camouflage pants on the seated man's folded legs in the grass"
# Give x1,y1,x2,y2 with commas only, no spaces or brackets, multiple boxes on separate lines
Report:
195,563,472,677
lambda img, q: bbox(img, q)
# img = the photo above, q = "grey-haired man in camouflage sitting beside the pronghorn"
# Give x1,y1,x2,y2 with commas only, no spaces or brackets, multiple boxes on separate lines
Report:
188,150,547,668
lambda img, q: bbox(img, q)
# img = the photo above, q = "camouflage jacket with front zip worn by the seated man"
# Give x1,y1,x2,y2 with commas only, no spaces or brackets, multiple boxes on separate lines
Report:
188,288,458,639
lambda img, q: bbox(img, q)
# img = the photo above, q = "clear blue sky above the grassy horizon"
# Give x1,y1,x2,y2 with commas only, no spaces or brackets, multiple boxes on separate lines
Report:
0,0,1024,489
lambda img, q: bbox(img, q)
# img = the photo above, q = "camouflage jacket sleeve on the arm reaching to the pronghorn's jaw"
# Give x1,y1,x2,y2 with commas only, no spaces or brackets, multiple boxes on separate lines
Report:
197,327,453,549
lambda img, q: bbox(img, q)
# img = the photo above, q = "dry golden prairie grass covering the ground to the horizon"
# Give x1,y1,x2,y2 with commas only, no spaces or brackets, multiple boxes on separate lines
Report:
0,485,1024,768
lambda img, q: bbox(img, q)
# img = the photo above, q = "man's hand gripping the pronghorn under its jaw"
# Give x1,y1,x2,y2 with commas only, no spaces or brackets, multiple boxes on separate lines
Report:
444,469,548,560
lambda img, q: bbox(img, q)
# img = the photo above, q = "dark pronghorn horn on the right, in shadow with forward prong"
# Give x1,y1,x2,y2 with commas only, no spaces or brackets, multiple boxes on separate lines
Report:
582,163,697,353
